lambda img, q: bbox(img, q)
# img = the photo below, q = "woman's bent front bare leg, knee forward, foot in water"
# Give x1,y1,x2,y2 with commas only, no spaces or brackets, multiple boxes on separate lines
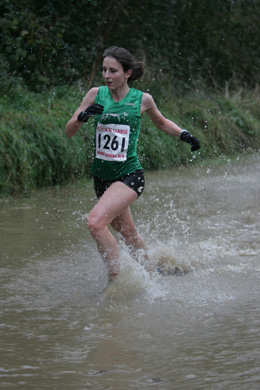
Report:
88,182,137,276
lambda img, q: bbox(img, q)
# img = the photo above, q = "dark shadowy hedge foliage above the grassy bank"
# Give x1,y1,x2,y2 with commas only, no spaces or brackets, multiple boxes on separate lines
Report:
0,0,260,90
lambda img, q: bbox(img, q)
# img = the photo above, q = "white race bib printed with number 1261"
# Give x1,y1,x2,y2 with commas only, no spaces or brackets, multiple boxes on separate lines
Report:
96,123,130,162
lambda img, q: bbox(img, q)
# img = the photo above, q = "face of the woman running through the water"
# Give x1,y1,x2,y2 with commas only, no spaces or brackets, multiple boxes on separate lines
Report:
102,57,132,90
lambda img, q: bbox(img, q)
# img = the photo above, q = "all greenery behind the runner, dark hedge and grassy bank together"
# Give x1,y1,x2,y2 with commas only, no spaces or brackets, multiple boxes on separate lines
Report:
0,0,260,196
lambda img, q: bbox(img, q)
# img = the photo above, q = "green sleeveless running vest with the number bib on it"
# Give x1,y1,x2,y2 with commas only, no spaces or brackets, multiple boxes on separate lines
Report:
91,87,143,180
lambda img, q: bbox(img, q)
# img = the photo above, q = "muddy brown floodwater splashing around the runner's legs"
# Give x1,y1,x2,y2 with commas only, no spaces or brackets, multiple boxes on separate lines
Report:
0,154,260,390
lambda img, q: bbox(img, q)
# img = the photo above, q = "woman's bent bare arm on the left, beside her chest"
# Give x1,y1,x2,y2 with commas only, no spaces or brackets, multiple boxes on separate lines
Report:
65,88,98,138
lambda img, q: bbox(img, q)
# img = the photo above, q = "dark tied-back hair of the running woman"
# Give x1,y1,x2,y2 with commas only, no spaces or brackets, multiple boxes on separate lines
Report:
103,46,144,81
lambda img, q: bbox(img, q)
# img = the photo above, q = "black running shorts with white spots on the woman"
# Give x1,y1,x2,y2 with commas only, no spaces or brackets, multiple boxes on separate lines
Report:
94,169,145,198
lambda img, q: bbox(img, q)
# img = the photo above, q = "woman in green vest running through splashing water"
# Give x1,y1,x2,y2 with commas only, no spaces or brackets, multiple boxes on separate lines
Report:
65,46,200,277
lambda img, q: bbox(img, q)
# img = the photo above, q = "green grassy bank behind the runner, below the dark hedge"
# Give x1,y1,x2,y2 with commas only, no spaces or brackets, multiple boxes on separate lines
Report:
0,87,260,196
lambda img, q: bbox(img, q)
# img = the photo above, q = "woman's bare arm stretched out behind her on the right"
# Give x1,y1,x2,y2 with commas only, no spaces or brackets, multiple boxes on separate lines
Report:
141,93,182,137
